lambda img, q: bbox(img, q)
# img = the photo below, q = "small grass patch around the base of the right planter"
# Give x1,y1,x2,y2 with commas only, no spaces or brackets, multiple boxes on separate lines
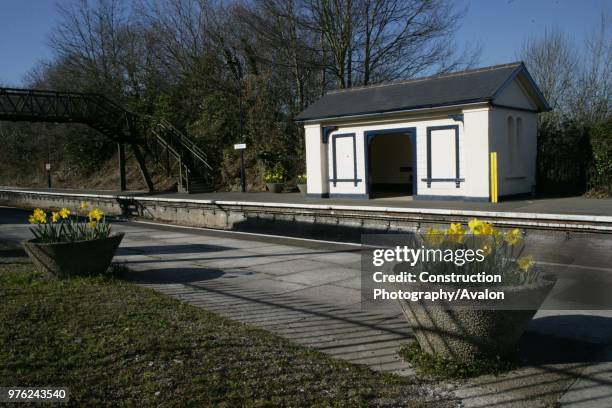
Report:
398,342,515,380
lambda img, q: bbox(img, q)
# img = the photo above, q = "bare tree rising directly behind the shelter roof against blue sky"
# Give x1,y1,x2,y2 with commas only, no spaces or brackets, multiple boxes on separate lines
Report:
305,0,480,88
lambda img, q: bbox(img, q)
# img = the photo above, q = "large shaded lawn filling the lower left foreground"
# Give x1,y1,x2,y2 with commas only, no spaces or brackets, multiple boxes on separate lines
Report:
0,244,453,407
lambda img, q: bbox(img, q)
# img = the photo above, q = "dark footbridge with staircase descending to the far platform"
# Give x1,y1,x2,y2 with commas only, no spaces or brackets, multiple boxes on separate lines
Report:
0,88,213,192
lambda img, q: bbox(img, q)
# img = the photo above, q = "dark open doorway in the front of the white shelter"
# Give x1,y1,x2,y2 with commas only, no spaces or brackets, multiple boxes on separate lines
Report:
367,129,416,198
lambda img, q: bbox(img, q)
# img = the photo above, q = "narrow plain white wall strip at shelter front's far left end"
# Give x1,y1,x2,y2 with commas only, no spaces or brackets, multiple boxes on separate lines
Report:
304,124,329,194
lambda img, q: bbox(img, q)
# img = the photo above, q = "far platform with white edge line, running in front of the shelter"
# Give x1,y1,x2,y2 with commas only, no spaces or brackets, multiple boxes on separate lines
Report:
0,188,612,237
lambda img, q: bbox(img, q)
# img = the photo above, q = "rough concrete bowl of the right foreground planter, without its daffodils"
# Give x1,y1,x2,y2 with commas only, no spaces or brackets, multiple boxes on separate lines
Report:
401,277,556,362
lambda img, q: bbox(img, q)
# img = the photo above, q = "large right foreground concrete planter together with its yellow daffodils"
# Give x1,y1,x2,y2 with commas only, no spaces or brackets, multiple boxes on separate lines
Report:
394,219,556,362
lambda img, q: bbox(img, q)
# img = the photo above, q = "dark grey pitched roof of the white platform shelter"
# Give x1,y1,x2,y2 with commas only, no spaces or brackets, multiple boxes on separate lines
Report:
296,62,549,121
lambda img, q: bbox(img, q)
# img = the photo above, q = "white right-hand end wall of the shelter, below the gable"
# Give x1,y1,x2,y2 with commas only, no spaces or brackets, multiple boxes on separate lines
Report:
491,108,537,196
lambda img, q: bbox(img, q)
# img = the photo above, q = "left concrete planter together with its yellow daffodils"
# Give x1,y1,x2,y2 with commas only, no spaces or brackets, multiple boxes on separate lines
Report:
23,202,124,278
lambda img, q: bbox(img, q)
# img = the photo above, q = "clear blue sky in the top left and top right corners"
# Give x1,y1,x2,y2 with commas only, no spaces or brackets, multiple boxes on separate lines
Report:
0,0,612,86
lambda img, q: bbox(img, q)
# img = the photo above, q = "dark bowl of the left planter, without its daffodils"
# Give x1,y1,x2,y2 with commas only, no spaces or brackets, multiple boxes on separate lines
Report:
22,233,124,278
